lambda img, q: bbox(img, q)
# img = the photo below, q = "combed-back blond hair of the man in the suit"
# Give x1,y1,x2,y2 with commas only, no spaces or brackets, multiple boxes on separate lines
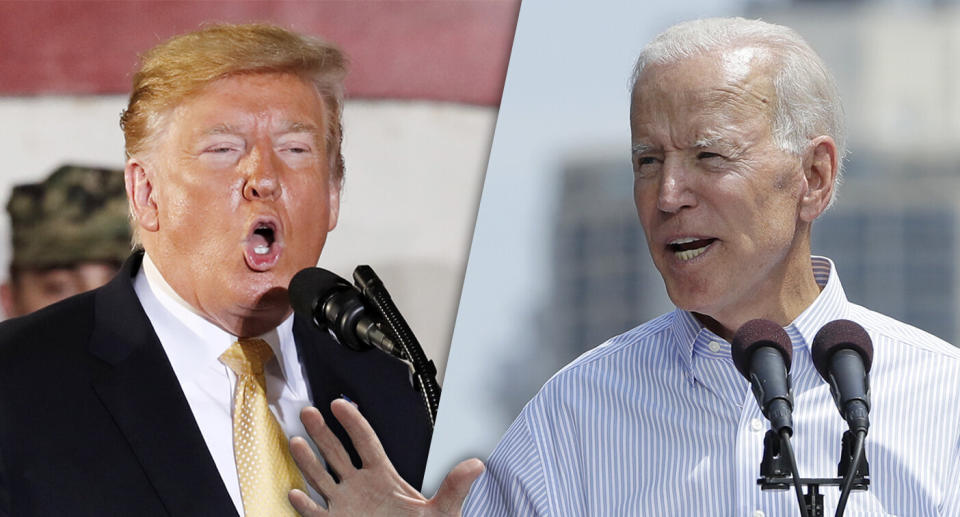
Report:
120,23,347,186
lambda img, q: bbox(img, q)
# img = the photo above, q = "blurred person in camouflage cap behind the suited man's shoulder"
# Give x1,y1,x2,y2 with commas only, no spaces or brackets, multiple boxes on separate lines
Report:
0,165,130,318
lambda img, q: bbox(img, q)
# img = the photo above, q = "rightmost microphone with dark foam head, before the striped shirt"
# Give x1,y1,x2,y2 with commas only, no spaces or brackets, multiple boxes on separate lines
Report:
810,320,873,434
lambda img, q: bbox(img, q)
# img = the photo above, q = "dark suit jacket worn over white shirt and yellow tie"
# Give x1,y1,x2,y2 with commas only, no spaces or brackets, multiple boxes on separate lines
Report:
0,254,431,517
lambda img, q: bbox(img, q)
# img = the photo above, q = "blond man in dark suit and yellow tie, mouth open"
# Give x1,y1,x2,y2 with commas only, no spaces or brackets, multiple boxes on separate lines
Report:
0,24,430,516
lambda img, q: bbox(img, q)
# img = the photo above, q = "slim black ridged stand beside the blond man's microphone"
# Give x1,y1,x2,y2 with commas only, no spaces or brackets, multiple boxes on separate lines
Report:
353,265,440,427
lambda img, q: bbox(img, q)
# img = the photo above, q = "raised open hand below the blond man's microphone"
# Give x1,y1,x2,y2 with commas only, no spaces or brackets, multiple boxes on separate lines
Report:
290,399,483,517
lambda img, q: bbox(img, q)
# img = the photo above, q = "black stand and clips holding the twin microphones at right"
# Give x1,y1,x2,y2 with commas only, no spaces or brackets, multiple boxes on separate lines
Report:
757,430,870,517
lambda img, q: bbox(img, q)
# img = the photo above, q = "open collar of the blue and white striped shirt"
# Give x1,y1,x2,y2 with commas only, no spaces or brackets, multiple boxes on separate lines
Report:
670,256,848,376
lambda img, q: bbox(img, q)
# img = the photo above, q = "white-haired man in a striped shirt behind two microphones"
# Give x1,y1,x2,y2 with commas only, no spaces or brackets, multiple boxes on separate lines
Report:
297,18,960,516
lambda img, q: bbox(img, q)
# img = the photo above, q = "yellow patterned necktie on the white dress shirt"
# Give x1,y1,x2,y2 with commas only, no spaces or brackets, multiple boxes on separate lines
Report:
220,339,305,517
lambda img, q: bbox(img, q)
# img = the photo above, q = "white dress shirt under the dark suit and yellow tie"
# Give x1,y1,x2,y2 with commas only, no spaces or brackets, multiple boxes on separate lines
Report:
133,254,319,515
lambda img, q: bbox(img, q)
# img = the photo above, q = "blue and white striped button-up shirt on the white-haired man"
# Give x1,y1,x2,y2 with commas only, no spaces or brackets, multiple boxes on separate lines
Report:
464,257,960,517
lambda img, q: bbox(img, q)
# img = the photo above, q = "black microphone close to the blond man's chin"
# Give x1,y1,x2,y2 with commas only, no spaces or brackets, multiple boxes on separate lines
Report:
288,267,402,357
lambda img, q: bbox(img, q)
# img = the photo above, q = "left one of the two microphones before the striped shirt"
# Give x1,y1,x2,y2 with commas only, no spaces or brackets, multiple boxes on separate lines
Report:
732,319,793,435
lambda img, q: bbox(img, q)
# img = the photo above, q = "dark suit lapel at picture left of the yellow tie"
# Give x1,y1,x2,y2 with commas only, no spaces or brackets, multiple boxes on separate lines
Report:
90,254,236,515
